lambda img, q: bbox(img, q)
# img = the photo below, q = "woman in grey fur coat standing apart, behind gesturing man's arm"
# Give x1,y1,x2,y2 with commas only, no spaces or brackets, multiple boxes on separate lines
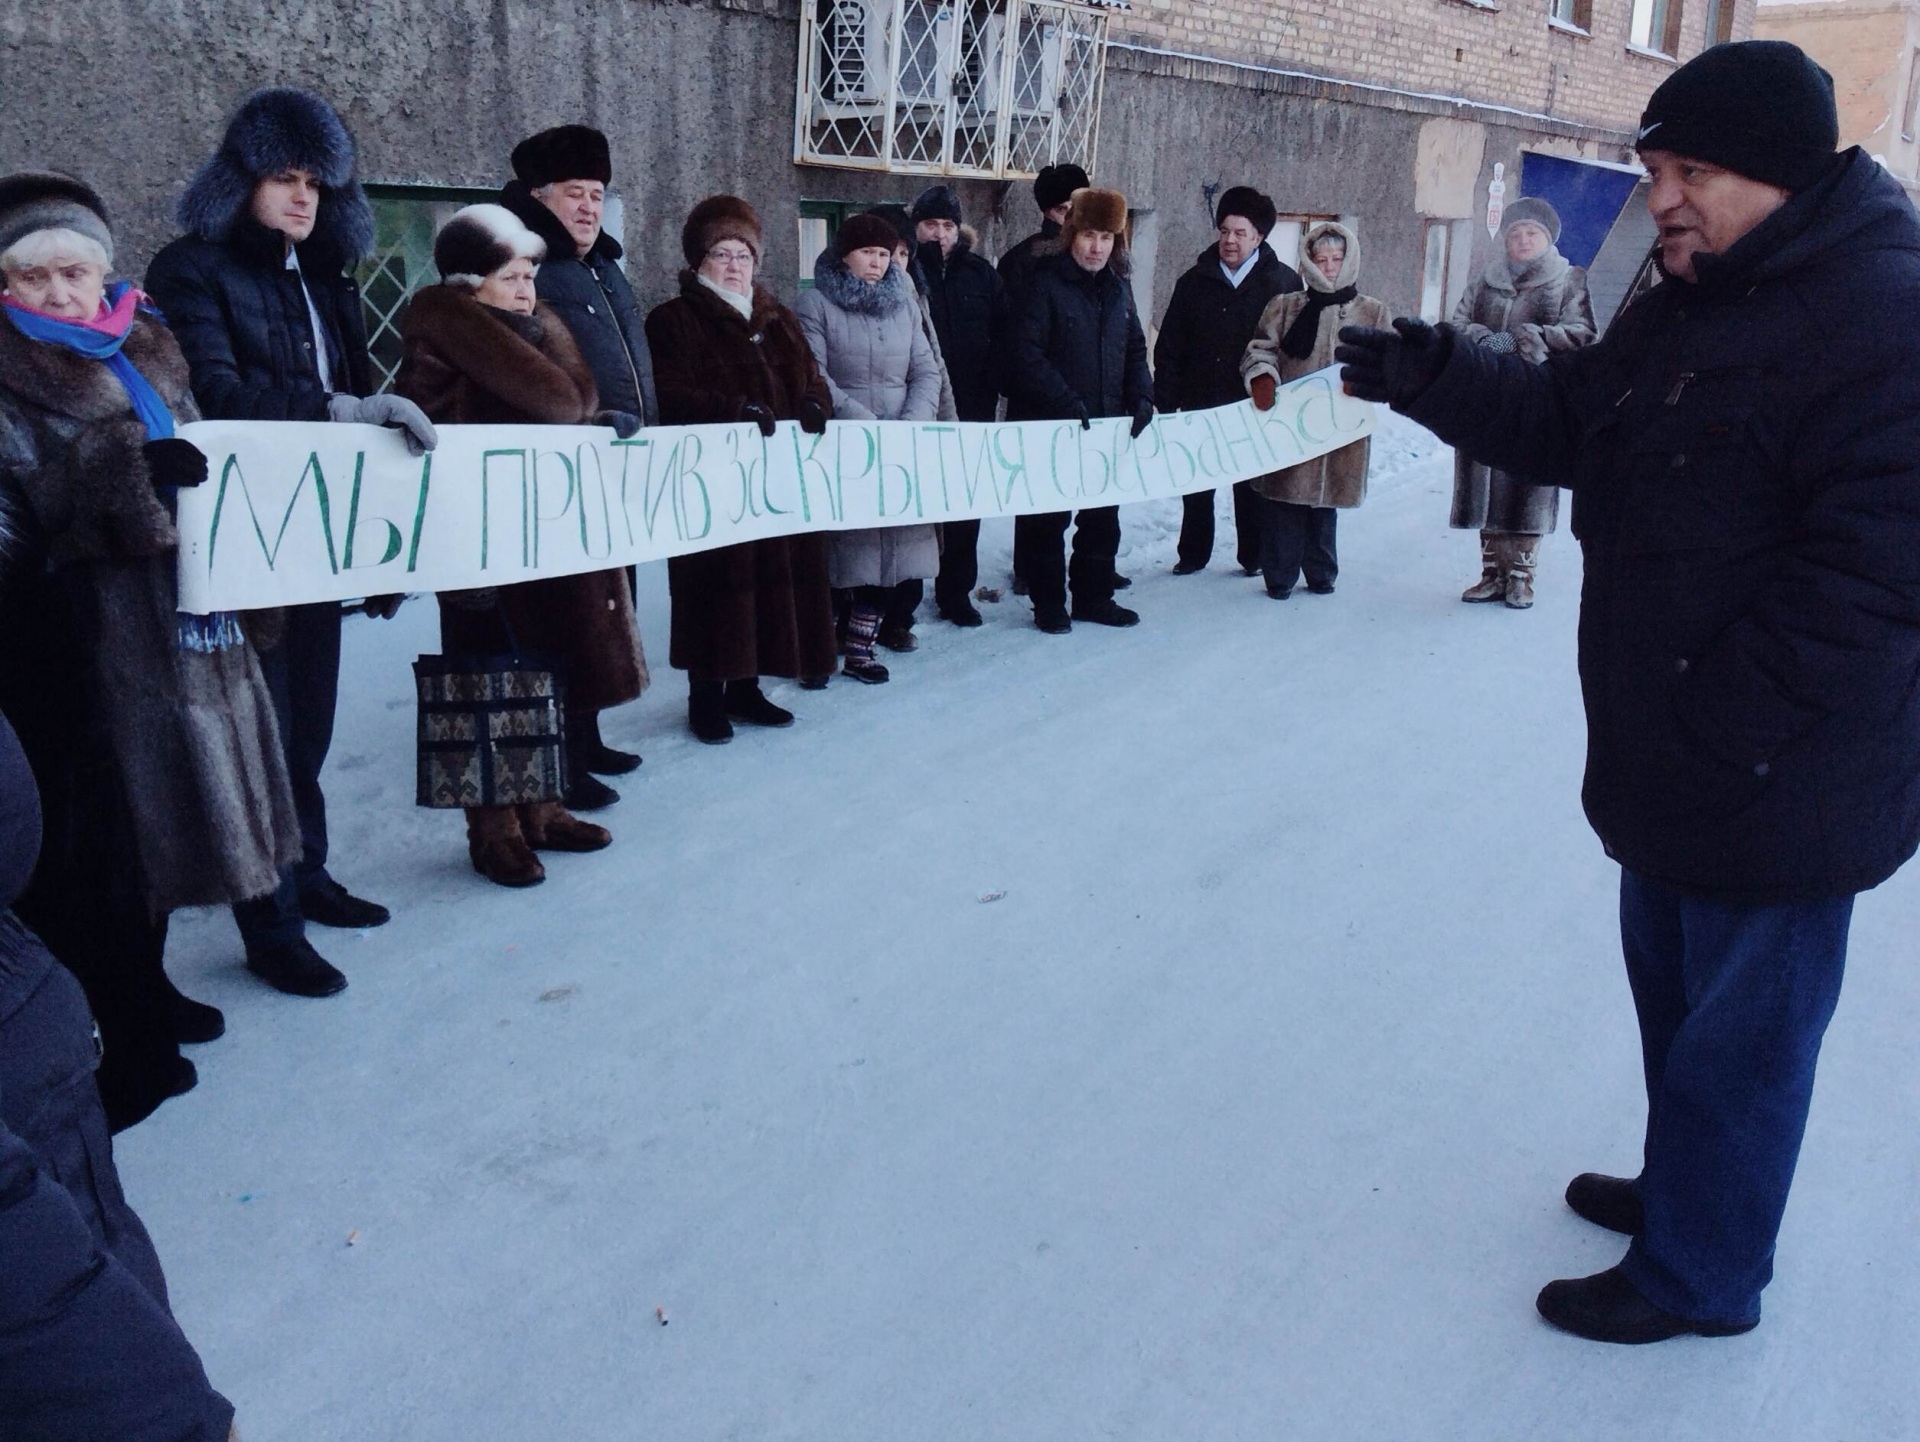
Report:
1448,196,1599,611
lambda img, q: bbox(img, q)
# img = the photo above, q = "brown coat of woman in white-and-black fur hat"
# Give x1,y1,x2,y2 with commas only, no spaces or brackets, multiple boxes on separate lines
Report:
394,284,647,710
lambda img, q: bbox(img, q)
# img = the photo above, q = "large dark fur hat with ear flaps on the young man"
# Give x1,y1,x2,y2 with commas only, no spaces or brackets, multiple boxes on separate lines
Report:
179,86,374,265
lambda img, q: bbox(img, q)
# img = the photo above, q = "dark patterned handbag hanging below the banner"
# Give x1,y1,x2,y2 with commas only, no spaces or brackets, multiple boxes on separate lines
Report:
413,634,566,808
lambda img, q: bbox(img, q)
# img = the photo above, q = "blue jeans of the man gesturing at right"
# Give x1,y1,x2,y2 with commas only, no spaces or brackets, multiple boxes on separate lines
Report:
1620,872,1853,1323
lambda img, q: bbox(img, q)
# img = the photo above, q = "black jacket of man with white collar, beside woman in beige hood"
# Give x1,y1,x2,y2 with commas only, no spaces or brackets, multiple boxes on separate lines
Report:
1154,246,1302,411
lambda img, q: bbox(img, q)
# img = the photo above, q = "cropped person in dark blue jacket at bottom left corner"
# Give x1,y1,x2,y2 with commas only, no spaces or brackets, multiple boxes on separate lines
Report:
0,716,234,1442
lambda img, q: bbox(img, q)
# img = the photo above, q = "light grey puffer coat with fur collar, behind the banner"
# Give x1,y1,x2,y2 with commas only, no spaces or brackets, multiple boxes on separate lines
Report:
795,253,941,588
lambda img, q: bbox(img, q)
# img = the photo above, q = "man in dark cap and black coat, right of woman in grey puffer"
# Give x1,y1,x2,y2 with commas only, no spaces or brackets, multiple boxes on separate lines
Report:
908,184,1002,626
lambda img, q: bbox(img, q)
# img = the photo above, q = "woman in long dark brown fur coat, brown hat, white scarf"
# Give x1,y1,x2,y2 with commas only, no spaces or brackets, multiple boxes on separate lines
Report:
647,196,835,745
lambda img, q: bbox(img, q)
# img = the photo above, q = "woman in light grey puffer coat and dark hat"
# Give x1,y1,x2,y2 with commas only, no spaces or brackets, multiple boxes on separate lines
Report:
797,215,941,685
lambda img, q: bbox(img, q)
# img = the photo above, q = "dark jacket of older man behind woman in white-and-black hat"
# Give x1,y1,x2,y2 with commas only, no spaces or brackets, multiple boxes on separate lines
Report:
499,180,660,426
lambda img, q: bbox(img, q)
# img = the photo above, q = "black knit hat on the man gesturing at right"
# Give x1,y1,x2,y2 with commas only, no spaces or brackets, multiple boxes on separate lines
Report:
1638,40,1839,190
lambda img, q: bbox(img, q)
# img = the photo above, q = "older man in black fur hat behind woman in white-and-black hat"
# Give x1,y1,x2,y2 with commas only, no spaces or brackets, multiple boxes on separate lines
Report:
499,125,660,810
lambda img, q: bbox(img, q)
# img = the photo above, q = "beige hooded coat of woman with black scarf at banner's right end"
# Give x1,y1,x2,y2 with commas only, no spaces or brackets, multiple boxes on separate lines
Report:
1240,221,1394,509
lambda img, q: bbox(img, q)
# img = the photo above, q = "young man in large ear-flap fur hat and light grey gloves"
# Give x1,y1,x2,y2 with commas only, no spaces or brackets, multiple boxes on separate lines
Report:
146,90,434,997
